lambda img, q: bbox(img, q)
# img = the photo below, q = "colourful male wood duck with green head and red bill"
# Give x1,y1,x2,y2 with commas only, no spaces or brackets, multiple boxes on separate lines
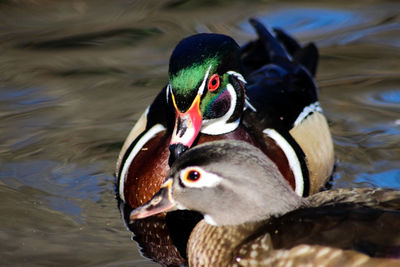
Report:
116,19,334,211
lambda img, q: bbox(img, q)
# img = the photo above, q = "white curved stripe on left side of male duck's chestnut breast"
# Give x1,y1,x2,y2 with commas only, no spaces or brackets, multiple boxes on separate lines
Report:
119,124,165,202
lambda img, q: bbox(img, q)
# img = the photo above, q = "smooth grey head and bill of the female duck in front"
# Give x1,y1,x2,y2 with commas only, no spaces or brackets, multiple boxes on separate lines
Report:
131,140,301,225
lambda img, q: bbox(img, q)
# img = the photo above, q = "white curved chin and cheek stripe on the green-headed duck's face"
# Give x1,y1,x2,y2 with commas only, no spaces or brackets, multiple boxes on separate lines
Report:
200,83,240,135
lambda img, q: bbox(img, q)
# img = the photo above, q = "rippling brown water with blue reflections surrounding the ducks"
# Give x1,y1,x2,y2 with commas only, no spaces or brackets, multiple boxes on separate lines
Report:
0,0,400,266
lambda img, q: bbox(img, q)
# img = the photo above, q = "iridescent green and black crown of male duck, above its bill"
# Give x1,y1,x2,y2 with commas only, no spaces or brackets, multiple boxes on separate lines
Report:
169,33,239,111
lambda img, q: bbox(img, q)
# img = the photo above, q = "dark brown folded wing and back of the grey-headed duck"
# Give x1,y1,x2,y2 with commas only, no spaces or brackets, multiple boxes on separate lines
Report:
263,188,400,259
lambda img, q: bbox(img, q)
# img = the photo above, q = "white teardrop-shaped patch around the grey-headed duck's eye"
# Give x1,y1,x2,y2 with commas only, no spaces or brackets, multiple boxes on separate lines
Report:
179,166,222,188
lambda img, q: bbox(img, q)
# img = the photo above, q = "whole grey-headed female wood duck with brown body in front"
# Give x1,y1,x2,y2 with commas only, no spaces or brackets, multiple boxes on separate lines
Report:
130,140,400,266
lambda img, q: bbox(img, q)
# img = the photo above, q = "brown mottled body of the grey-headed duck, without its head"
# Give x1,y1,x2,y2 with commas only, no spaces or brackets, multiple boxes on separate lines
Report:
187,188,400,266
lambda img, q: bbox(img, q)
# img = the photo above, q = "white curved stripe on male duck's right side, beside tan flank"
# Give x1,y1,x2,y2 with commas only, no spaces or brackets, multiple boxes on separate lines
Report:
263,129,304,196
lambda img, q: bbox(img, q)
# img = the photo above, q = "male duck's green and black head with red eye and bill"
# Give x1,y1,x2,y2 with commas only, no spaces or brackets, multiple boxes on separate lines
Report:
167,33,245,163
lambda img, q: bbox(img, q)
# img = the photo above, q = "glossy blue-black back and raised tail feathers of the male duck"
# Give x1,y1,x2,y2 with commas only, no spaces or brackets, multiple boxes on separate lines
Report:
242,19,320,131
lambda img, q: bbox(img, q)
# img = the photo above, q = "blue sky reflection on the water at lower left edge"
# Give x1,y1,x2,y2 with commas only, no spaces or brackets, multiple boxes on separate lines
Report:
0,160,106,218
